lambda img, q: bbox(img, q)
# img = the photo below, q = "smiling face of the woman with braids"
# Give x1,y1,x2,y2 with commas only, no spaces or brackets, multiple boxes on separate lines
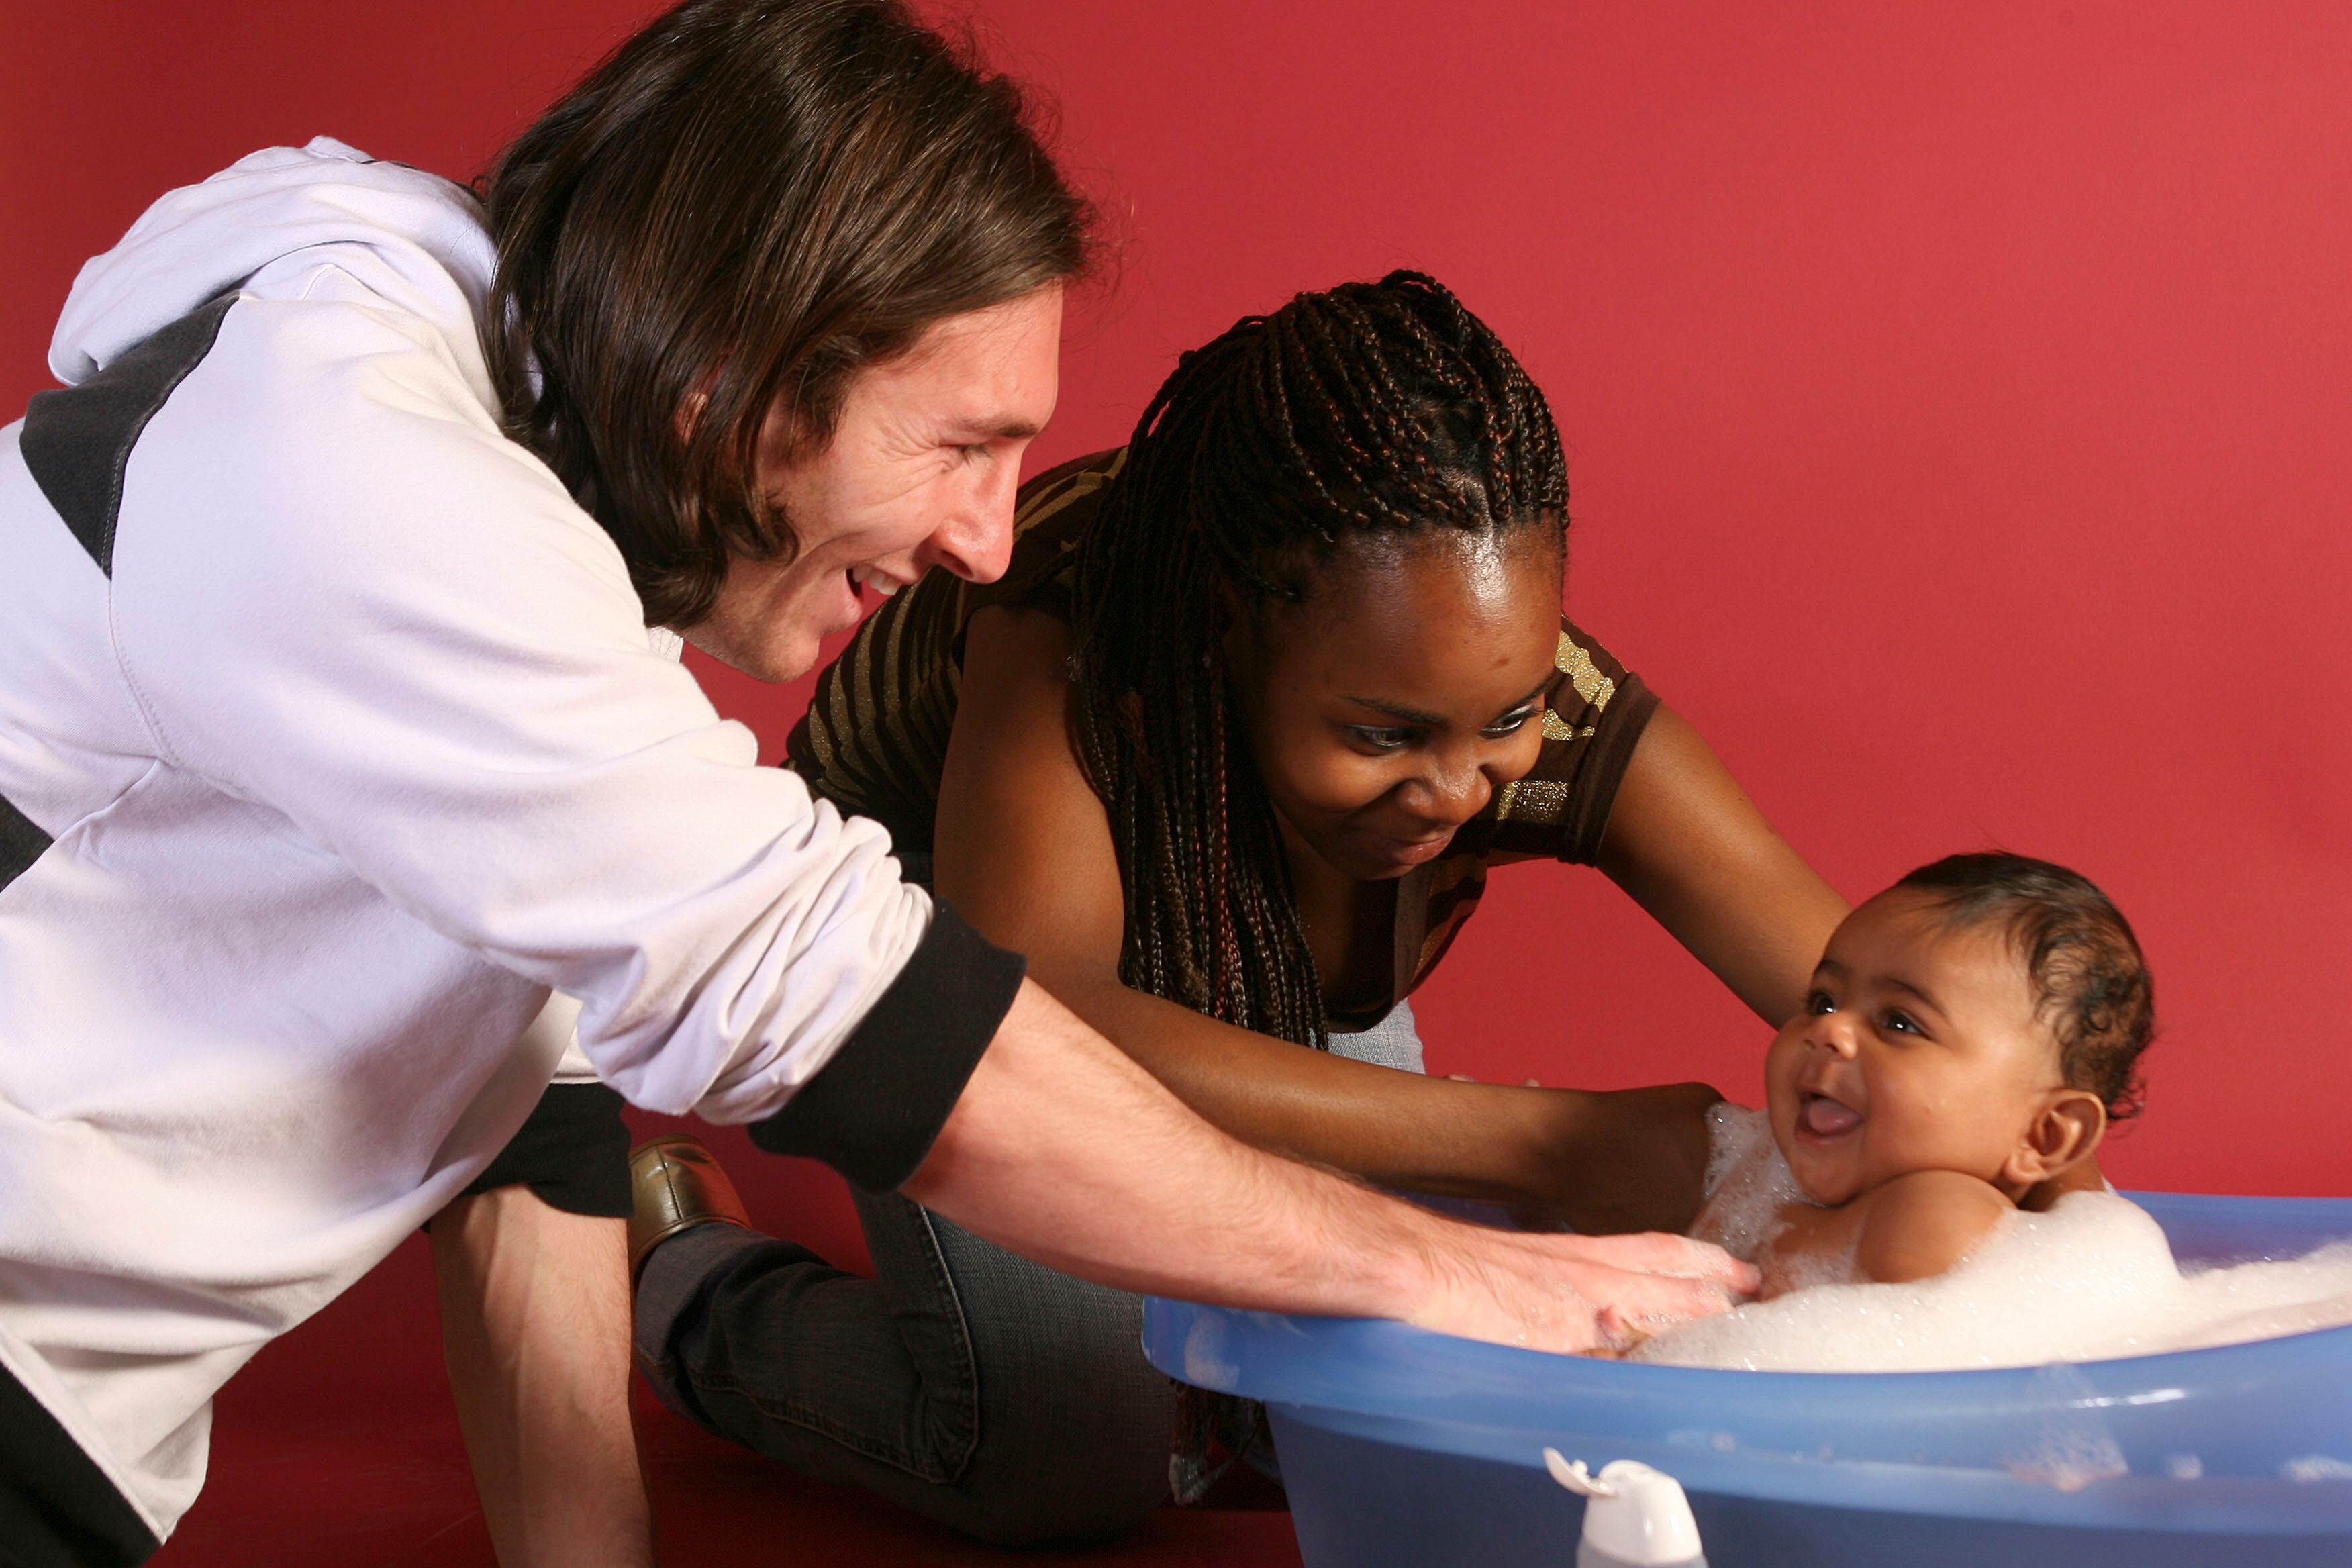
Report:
1228,527,1562,881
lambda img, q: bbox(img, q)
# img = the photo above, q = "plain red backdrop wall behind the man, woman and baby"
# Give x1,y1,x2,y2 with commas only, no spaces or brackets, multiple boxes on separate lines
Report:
0,0,2352,1204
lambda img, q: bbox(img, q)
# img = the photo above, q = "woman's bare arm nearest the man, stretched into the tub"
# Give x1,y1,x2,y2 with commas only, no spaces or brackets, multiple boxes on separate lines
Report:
934,609,1712,1232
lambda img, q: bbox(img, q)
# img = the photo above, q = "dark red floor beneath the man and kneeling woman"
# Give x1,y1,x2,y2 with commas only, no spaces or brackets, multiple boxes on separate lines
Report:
155,1133,1298,1568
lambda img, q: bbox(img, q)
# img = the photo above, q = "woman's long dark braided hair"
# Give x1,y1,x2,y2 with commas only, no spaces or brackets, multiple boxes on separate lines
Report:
1073,273,1569,1048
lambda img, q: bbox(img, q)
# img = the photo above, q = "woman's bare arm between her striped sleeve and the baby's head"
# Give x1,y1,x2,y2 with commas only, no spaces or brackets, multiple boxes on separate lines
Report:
1600,707,1847,1027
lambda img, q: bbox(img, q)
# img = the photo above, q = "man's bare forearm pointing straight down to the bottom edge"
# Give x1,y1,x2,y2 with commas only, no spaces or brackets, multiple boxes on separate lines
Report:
430,1187,654,1568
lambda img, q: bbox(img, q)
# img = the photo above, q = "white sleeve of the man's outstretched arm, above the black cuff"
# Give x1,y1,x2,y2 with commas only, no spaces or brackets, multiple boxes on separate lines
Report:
115,299,932,1122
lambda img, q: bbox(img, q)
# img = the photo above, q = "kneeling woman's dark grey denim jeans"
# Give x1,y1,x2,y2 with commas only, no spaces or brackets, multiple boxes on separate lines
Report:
638,1003,1420,1547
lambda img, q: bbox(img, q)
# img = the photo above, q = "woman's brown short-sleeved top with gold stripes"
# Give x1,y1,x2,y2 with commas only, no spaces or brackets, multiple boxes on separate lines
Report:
785,449,1658,999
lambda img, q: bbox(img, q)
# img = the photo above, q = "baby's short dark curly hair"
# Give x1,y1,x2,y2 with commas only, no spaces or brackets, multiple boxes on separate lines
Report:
1896,851,2157,1122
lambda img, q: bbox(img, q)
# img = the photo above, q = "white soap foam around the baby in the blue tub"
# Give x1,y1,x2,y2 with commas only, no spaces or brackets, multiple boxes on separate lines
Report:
1630,1108,2352,1373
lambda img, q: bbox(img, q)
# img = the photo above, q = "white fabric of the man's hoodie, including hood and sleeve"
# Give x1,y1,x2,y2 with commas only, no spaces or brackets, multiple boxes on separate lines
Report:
0,139,932,1537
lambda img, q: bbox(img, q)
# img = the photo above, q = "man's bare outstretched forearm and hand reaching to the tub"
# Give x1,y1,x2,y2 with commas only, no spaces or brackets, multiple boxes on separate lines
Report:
903,980,1755,1349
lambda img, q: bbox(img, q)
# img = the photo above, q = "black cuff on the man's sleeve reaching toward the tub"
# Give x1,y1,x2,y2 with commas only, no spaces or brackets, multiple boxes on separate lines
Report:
750,900,1028,1192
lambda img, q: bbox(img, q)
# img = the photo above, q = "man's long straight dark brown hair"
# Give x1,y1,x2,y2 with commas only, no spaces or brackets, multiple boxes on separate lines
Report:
482,0,1091,626
